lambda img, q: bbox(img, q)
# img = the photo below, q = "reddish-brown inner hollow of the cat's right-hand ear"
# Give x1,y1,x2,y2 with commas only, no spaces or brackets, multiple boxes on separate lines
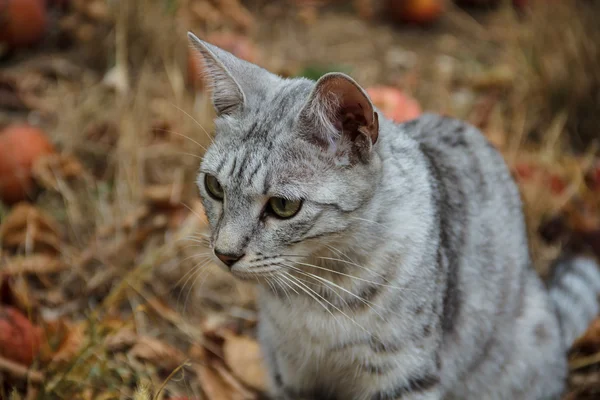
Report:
317,74,379,144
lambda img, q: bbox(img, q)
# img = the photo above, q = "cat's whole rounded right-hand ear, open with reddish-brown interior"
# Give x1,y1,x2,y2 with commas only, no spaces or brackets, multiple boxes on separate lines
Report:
300,73,379,151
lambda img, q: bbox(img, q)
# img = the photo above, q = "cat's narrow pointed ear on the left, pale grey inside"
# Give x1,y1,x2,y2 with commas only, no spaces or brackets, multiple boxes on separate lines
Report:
188,32,247,115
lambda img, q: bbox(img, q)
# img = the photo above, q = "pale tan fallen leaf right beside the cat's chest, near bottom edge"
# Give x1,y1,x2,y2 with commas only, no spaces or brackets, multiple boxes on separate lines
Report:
223,335,267,391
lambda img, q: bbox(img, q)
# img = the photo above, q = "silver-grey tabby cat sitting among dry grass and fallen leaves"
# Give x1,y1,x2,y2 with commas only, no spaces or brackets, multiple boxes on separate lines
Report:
189,34,600,400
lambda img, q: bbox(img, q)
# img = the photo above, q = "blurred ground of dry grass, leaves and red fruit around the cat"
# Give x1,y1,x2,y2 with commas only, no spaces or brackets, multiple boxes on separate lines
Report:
0,0,600,400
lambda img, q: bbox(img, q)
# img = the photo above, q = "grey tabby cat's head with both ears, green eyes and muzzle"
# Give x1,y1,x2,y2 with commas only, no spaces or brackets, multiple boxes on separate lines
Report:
189,34,381,278
